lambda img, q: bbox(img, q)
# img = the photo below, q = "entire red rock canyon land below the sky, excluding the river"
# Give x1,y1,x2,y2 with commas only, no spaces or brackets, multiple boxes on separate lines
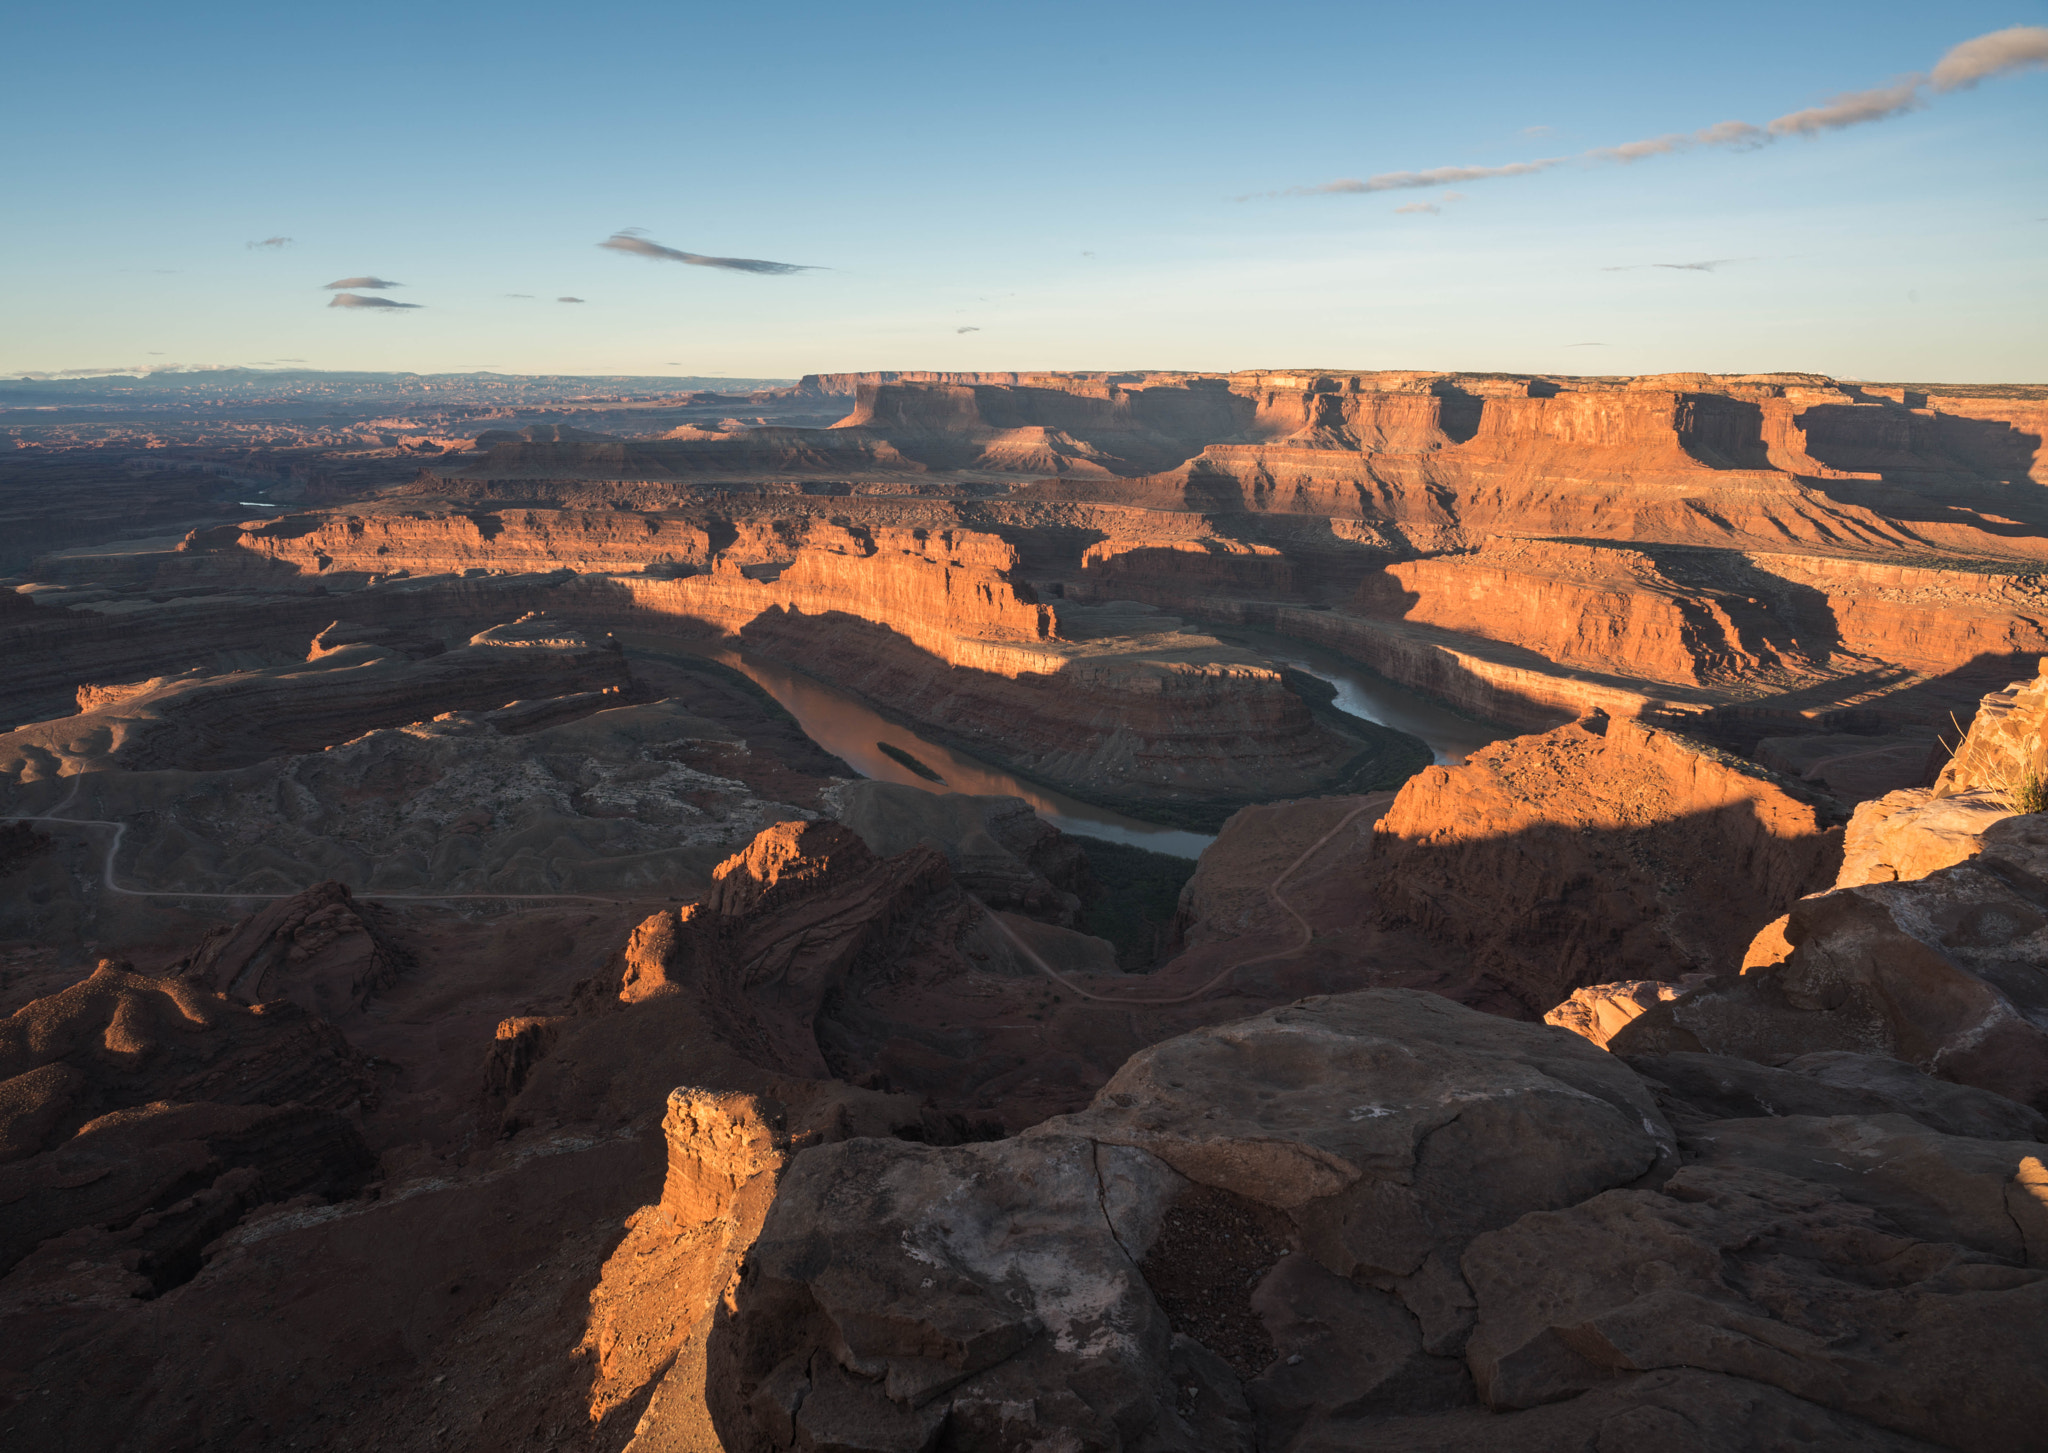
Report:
0,371,2048,1453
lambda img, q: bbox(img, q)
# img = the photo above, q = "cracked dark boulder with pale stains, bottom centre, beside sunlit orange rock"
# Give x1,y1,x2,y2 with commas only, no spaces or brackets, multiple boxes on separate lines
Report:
711,1135,1251,1453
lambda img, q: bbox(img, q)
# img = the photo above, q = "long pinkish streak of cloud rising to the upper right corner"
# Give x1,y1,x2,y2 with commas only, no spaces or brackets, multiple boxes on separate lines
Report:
1261,25,2048,199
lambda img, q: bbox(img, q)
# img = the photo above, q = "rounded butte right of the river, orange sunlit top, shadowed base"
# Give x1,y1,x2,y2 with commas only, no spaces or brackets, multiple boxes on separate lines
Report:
1364,717,1839,1014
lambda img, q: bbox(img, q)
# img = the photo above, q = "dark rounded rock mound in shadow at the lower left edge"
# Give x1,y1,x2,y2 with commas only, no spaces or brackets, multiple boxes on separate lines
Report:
0,961,377,1295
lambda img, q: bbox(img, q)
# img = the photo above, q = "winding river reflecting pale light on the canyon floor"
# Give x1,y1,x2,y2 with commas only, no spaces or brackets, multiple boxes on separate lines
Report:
647,631,1507,859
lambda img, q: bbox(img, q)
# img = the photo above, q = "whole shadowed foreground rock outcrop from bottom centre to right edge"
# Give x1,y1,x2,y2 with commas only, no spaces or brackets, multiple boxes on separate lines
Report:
711,992,2048,1453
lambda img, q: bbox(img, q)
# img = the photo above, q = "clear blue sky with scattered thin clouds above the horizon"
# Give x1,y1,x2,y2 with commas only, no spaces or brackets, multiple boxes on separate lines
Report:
0,0,2048,383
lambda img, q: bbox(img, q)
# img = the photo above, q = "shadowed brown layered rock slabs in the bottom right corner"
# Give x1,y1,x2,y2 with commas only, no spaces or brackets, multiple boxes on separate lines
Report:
1464,1139,2048,1449
